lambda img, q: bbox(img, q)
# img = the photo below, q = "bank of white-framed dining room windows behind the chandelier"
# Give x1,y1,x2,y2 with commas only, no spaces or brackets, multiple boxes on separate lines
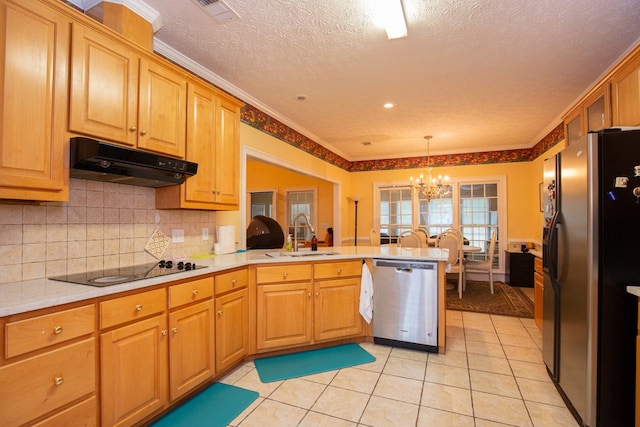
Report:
374,177,507,269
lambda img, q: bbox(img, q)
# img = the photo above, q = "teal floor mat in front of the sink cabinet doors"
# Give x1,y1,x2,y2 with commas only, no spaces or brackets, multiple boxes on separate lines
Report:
254,344,376,383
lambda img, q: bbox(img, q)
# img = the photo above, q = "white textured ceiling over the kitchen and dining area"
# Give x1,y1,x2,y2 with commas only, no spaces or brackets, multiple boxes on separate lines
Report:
144,0,640,161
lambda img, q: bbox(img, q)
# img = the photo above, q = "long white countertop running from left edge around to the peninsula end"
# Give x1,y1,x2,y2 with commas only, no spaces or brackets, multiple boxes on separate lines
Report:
0,245,447,317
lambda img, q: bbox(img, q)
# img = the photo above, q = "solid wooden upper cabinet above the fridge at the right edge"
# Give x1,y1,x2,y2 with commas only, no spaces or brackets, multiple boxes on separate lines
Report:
611,47,640,126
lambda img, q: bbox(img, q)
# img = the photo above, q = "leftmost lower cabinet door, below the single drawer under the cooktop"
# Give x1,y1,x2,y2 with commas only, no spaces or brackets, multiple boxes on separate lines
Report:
100,315,168,426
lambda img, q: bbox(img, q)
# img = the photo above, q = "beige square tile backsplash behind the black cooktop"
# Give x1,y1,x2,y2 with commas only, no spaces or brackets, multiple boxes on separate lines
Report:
0,179,216,283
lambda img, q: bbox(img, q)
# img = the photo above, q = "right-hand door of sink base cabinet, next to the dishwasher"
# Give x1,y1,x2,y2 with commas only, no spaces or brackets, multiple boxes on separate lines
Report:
313,277,362,341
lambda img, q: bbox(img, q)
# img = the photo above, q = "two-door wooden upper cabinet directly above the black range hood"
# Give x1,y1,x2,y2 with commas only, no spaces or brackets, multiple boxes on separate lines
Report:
69,24,186,158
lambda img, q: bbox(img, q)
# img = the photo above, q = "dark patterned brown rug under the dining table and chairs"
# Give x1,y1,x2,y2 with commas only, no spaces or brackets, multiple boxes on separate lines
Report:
447,280,533,319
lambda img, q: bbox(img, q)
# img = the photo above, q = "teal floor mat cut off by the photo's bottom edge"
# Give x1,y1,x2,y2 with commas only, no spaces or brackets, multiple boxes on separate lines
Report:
151,383,259,427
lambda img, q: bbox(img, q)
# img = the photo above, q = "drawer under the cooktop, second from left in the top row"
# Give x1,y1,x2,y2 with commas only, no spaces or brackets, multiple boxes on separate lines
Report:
100,289,167,329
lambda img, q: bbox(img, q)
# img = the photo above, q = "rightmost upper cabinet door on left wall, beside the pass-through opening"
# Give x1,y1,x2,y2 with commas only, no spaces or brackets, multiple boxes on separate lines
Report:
215,98,240,208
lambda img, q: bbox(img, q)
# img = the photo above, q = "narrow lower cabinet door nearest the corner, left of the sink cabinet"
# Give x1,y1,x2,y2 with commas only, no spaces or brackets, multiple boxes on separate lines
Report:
216,288,249,371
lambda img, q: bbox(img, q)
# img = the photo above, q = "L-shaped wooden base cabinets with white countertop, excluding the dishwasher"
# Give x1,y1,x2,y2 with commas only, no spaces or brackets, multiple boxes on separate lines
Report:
0,246,447,425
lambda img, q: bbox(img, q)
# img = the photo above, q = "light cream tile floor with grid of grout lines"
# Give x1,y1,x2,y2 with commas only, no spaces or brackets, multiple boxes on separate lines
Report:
222,311,578,427
